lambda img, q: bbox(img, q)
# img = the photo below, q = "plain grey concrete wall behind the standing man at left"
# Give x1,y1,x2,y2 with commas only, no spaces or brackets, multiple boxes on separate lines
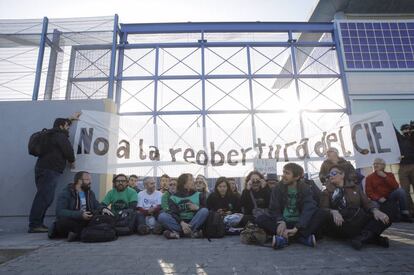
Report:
0,100,115,217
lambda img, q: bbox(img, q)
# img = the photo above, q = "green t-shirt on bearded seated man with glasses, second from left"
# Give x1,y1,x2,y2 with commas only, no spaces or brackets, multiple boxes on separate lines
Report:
102,187,138,214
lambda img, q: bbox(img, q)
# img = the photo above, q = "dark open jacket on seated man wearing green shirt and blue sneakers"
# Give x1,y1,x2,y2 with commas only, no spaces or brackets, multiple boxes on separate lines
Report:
267,181,318,229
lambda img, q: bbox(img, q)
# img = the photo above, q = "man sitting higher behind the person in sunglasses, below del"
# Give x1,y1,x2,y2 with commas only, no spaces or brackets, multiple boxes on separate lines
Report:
319,147,358,185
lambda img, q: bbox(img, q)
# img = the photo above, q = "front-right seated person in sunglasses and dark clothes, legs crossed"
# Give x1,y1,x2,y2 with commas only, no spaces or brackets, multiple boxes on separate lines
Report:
320,165,391,250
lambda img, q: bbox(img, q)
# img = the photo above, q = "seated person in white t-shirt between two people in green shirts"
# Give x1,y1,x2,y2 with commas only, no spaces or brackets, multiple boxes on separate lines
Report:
137,177,162,235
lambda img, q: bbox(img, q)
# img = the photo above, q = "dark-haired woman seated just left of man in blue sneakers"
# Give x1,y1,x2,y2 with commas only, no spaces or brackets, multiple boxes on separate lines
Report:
240,171,270,226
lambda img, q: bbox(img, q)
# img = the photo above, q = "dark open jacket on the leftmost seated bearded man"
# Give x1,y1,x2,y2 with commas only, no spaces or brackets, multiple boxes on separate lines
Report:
56,183,103,220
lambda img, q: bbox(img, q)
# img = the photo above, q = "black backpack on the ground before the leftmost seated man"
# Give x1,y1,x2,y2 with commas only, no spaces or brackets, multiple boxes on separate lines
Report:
81,215,117,243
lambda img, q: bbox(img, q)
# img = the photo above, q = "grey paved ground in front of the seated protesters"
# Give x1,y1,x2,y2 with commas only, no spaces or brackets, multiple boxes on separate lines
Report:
0,219,414,275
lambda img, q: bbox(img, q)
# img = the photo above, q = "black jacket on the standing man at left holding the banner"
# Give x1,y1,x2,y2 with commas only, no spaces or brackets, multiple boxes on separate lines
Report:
36,128,75,173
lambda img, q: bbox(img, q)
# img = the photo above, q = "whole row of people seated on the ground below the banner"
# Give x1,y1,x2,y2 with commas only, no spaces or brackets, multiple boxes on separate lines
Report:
49,150,411,250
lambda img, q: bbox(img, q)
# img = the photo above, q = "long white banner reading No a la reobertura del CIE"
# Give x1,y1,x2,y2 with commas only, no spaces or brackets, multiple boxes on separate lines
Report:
73,110,400,176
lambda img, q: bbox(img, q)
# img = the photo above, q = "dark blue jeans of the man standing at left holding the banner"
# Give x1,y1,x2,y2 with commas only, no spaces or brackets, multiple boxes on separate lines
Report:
29,167,60,228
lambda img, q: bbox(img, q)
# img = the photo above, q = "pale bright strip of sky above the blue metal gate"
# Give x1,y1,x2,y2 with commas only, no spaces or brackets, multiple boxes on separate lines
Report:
0,0,318,23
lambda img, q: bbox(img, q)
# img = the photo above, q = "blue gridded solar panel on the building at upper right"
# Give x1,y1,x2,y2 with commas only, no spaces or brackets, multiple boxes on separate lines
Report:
339,21,414,71
